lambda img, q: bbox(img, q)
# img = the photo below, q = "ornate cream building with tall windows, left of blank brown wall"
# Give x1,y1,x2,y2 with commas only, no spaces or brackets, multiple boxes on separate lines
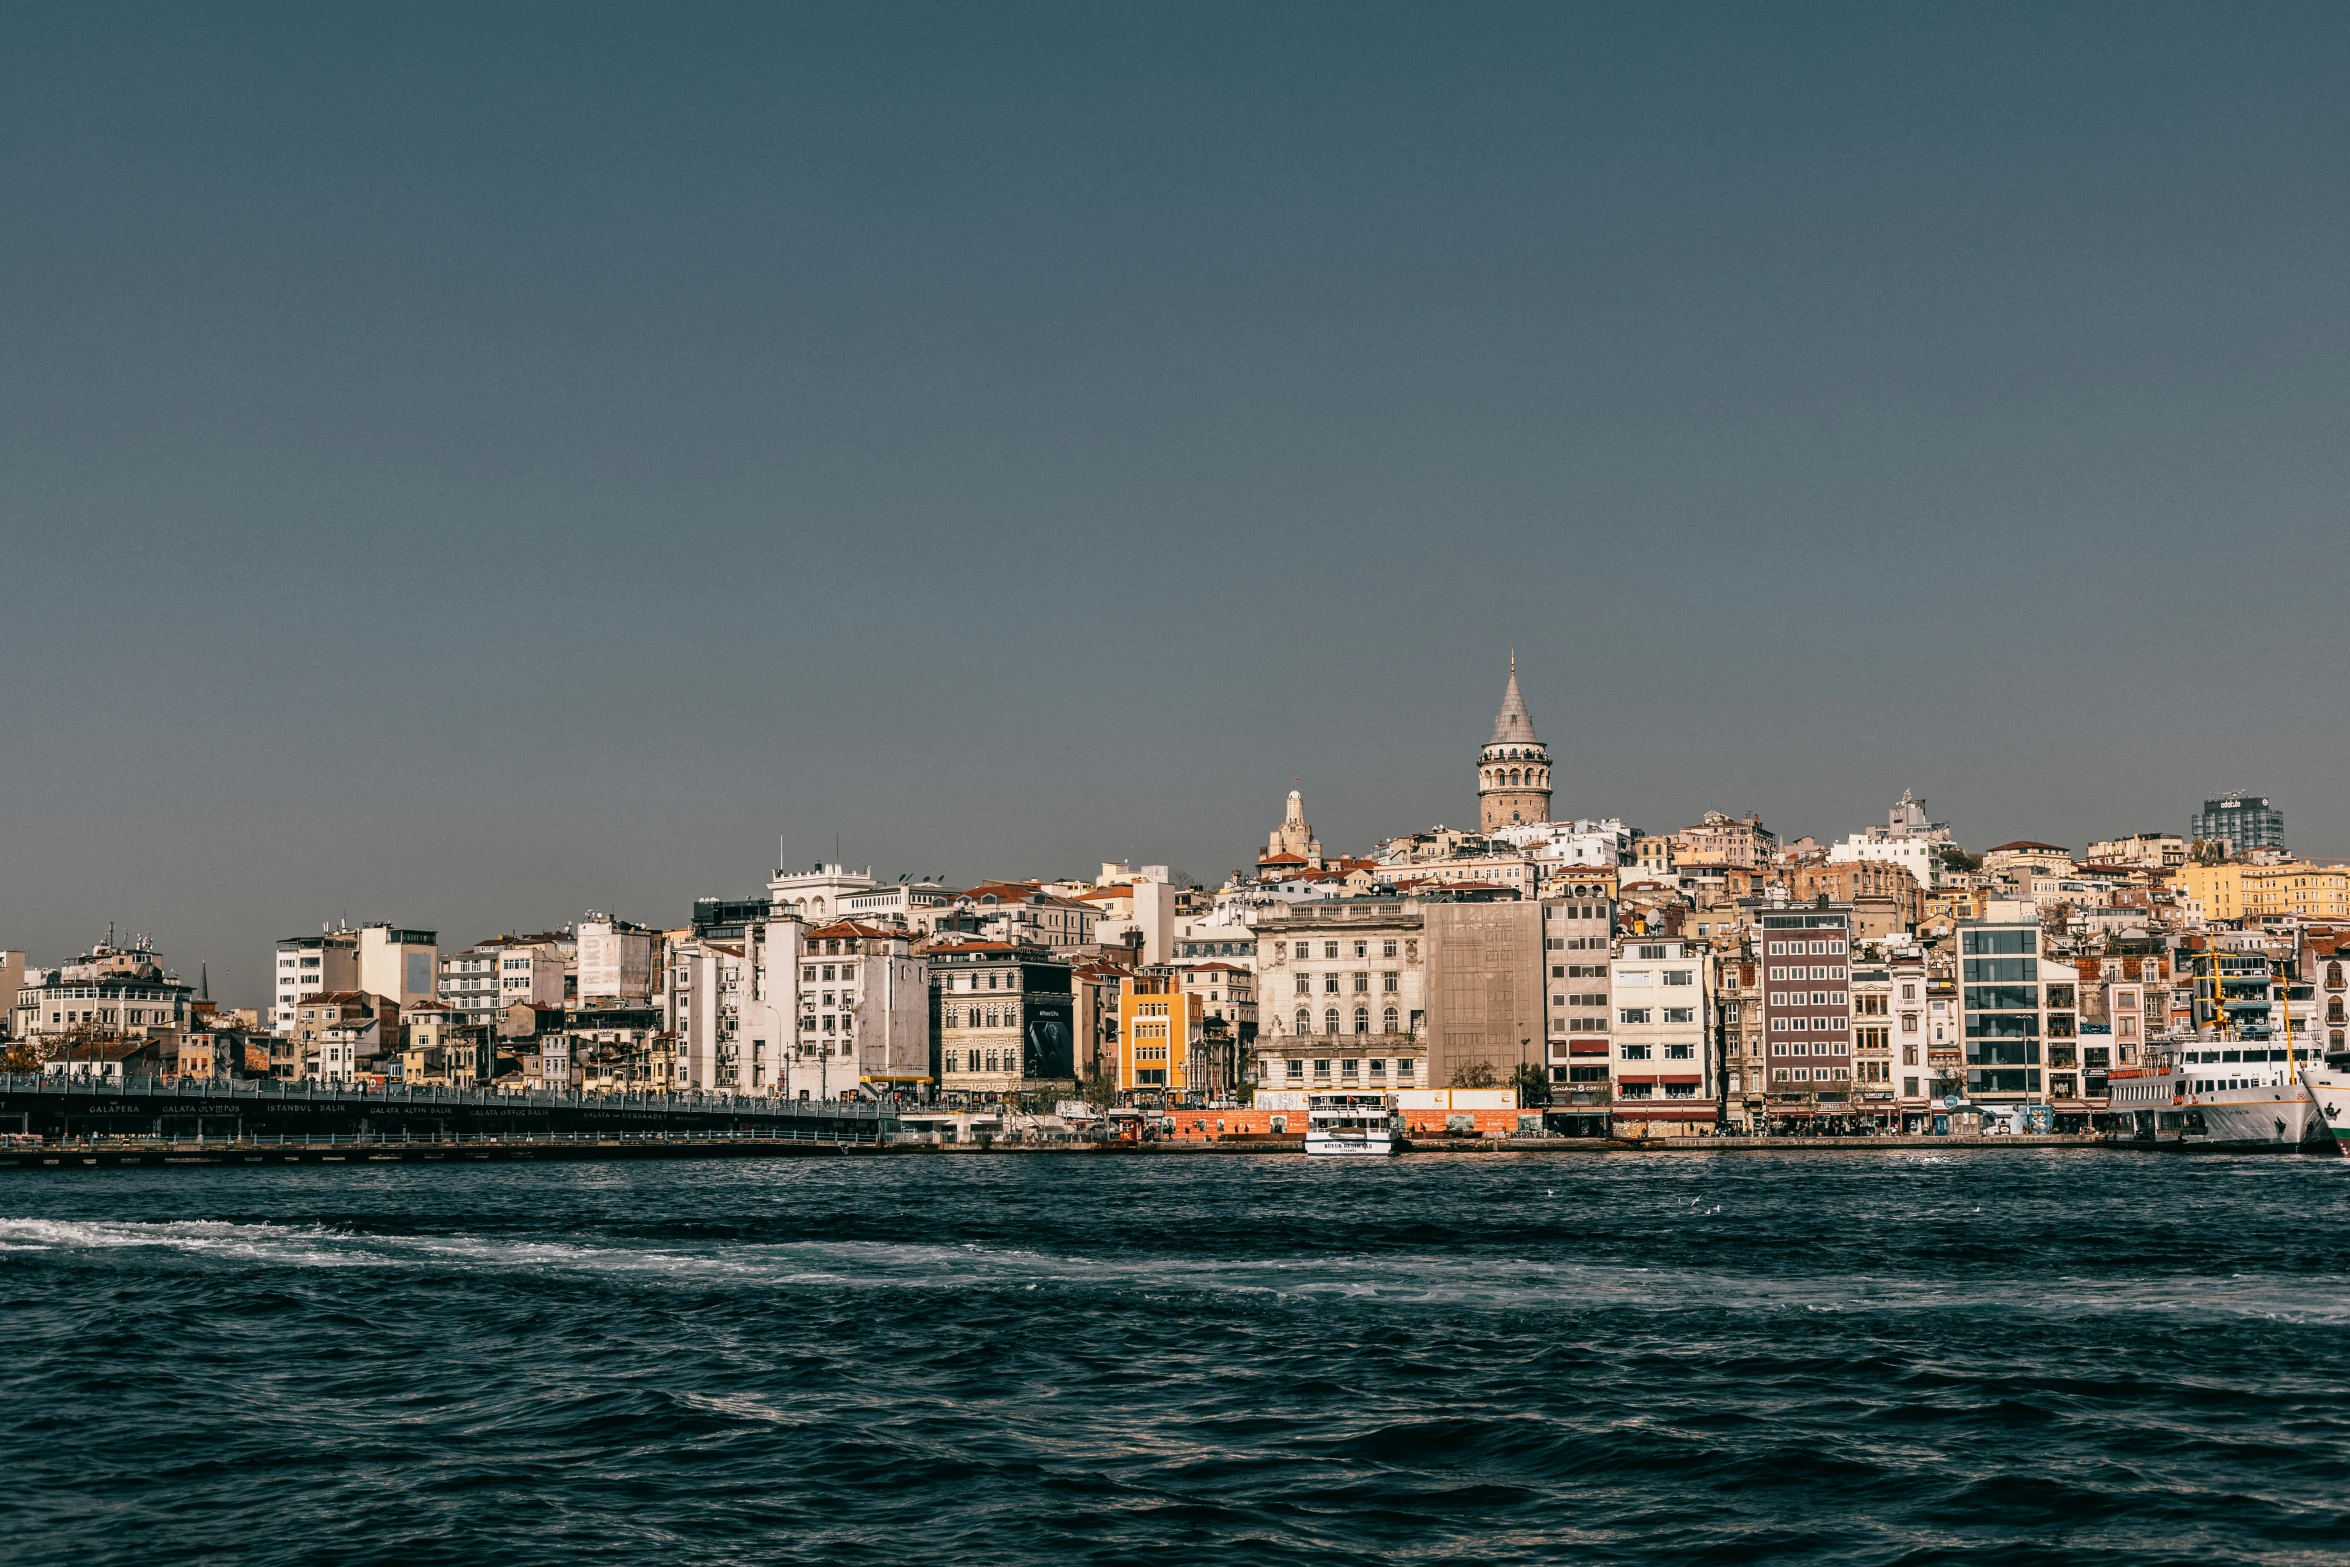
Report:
1255,897,1419,1090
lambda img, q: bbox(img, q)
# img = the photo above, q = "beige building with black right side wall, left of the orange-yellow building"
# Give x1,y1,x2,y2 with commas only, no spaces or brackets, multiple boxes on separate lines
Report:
926,942,1081,1102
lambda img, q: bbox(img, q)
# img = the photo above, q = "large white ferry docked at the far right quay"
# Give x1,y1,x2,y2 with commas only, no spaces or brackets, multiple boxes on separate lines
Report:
2106,1038,2321,1151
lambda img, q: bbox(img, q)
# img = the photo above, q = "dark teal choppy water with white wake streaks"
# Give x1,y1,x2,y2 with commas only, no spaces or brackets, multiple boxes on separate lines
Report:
0,1151,2350,1567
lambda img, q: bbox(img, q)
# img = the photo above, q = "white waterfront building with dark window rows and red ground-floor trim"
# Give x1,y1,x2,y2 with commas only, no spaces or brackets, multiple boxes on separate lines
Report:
1610,935,1718,1137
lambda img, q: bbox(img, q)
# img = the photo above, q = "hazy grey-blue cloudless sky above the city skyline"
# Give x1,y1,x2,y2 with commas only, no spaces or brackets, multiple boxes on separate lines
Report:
0,2,2350,1003
